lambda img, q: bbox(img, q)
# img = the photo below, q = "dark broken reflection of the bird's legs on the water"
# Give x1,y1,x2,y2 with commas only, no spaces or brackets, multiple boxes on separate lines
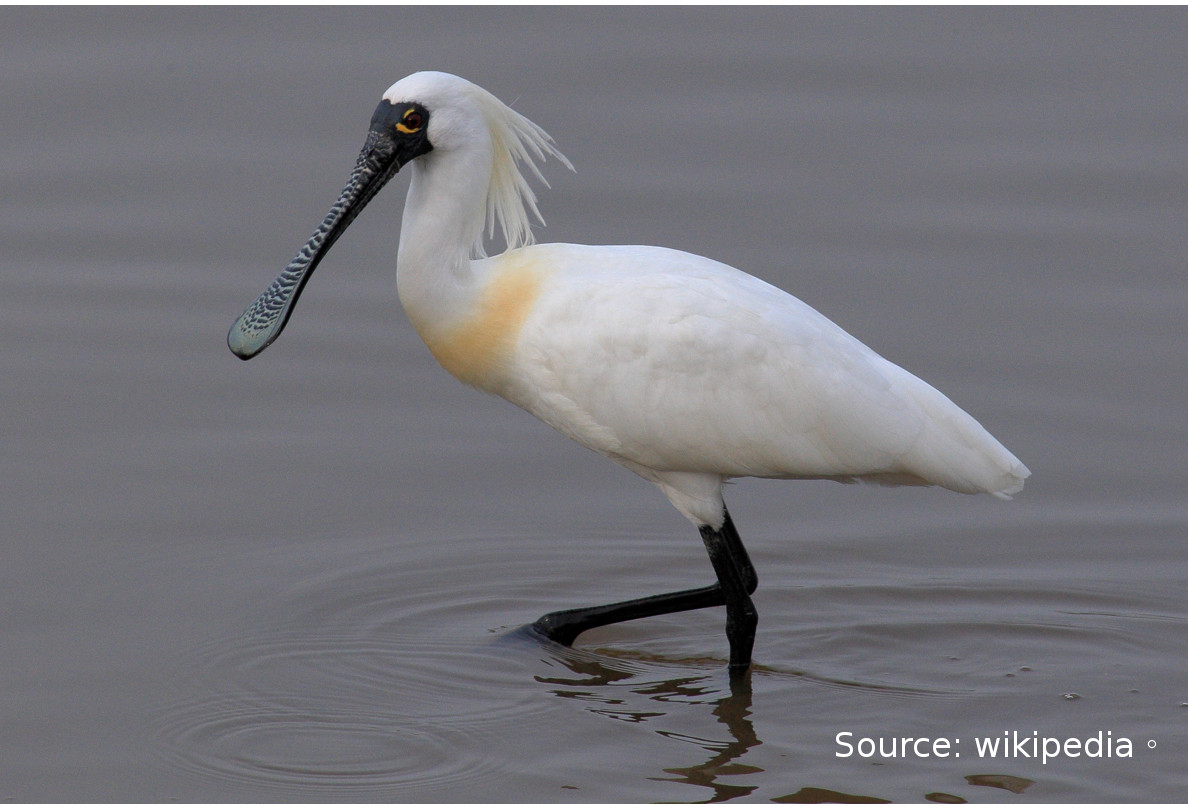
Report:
537,651,763,802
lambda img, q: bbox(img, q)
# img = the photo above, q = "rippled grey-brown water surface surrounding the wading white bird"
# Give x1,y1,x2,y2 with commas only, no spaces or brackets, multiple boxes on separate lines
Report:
0,8,1188,802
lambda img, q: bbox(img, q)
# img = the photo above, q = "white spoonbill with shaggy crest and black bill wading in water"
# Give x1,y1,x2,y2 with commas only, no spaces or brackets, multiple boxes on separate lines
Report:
227,72,1030,675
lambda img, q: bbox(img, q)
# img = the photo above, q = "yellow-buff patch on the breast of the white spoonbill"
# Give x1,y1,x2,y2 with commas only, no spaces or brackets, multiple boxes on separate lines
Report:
425,264,541,390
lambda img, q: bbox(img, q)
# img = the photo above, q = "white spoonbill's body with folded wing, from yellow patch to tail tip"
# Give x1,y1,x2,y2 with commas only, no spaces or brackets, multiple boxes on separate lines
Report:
504,239,1028,495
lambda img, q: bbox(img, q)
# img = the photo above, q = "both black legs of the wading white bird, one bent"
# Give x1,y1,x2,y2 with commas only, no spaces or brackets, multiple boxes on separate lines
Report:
532,512,759,675
